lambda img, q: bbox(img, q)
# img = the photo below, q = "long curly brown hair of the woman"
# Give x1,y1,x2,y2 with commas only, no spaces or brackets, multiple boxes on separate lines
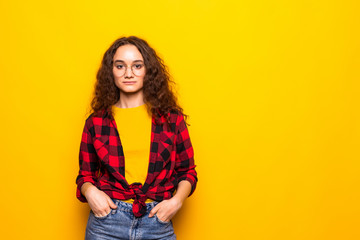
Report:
91,36,190,125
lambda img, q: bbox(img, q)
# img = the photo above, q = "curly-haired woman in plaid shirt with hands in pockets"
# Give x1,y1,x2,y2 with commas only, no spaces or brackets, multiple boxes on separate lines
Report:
76,36,198,240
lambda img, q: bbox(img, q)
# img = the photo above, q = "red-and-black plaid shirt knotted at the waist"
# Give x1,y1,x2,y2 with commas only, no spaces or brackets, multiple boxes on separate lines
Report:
76,110,198,217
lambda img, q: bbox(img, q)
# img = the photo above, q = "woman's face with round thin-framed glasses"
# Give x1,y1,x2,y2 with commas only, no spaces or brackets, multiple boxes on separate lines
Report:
113,44,146,93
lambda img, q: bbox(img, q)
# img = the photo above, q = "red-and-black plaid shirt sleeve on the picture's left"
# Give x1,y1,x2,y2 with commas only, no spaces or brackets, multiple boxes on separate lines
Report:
76,118,99,202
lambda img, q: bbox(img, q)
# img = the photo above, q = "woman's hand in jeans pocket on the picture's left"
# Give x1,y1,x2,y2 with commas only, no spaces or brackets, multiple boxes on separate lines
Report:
84,185,117,217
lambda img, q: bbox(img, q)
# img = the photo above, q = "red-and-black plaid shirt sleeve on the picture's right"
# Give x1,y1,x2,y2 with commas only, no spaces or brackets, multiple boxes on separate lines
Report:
175,114,198,197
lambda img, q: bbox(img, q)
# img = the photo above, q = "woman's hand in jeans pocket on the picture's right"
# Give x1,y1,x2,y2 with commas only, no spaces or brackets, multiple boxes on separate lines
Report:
149,197,182,222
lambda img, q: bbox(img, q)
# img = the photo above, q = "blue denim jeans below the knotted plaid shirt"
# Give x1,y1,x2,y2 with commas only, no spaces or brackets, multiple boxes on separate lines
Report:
85,198,176,240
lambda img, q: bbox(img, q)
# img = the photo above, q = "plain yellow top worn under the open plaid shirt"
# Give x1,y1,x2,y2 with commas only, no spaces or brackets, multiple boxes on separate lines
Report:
113,104,153,203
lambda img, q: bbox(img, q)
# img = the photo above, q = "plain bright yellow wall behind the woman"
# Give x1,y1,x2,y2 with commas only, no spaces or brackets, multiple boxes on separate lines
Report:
0,0,360,240
